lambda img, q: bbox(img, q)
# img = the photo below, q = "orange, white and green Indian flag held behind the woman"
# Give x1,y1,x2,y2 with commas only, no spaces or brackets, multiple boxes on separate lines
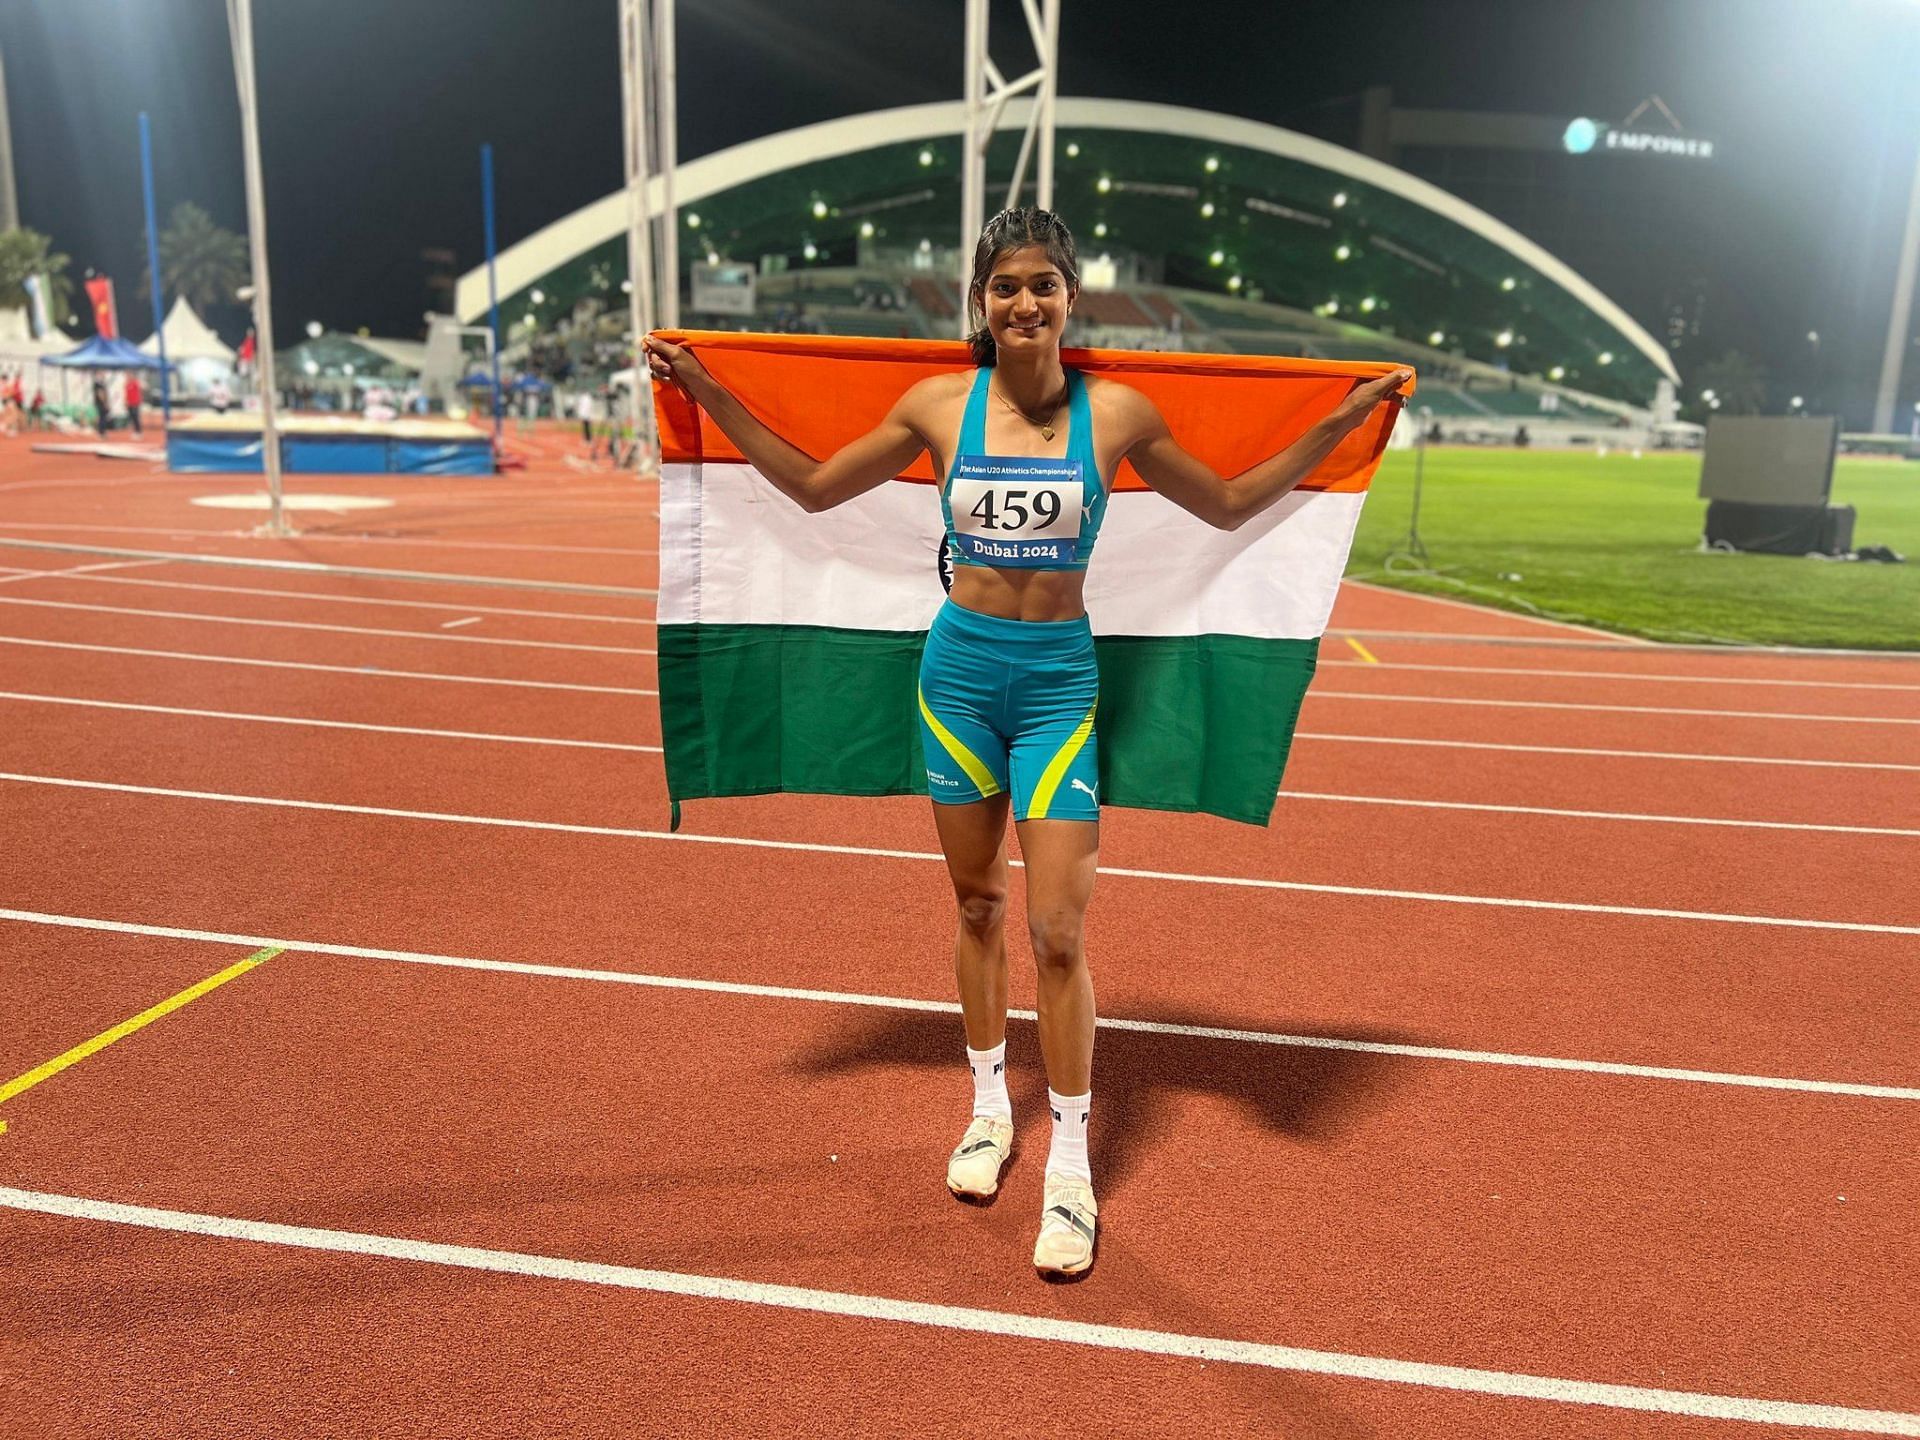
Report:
655,332,1396,826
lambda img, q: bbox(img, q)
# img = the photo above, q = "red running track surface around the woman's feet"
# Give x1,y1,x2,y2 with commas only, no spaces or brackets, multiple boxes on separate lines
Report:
0,430,1920,1436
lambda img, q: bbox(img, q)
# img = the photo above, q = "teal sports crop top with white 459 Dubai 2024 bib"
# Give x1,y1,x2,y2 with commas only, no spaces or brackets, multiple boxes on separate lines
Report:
941,365,1106,570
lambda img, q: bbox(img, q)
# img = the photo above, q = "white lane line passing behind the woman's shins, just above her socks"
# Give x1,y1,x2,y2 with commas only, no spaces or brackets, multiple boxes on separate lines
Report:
0,910,1920,1102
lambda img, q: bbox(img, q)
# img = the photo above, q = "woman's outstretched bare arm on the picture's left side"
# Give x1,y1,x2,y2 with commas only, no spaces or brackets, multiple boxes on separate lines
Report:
645,334,927,511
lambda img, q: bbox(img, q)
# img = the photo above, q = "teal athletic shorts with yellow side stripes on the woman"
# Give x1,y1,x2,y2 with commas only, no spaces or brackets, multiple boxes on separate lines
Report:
920,601,1100,820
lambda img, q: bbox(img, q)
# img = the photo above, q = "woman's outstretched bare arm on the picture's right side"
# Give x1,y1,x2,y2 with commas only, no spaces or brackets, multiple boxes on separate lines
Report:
1125,371,1413,530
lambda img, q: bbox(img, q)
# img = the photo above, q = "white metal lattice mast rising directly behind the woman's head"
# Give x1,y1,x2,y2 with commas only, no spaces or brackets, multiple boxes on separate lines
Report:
960,0,1060,340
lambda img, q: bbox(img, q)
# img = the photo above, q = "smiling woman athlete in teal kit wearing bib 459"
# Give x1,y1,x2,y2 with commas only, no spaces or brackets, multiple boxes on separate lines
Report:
645,207,1411,1275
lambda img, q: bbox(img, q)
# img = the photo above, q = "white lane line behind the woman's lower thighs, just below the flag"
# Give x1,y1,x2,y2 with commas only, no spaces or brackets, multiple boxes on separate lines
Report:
0,772,1920,935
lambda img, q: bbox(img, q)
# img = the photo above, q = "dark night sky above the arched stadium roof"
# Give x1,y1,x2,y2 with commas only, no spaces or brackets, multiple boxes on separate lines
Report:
0,0,1920,424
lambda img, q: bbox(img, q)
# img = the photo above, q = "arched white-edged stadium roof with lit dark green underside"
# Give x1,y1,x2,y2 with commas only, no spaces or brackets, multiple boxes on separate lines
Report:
455,98,1678,403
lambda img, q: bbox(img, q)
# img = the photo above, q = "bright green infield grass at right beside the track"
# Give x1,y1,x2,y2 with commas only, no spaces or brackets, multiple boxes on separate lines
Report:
1346,447,1920,649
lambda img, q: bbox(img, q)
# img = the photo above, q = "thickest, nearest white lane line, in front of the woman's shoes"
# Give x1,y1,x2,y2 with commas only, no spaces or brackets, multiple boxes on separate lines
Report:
0,1187,1920,1436
